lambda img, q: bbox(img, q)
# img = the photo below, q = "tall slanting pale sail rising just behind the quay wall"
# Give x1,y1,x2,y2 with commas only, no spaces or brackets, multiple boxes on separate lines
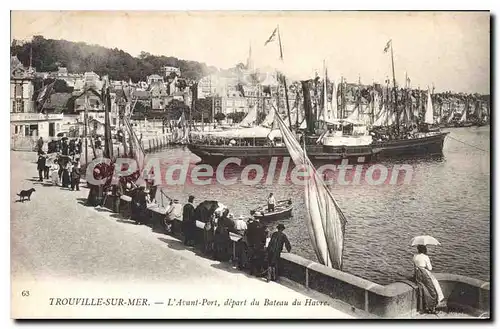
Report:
275,109,346,270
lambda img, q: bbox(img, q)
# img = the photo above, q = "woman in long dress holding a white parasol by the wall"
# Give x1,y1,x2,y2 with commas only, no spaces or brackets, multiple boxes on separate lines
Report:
412,235,444,314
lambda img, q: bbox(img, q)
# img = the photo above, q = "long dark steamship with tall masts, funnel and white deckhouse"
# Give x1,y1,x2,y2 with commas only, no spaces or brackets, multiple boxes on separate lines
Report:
188,34,448,163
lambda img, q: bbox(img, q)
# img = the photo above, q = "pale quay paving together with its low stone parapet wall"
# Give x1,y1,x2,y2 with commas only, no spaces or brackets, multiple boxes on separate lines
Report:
11,152,490,318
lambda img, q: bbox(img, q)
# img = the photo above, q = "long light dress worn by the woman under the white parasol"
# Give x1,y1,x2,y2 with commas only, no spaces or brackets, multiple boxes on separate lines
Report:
413,254,444,313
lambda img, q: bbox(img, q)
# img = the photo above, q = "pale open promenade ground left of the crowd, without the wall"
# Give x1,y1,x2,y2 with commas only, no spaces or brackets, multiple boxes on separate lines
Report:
11,152,358,318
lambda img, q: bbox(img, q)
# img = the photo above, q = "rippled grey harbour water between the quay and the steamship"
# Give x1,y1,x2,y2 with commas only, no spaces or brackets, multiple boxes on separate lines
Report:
148,126,490,284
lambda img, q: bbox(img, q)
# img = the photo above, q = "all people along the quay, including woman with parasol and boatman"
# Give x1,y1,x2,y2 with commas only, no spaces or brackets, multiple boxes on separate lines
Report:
31,138,444,313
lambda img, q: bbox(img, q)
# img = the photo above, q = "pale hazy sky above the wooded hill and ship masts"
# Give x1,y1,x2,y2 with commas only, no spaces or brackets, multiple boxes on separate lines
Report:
11,11,490,94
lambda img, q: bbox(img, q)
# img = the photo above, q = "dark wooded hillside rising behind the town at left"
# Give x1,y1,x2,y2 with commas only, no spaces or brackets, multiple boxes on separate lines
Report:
11,35,216,82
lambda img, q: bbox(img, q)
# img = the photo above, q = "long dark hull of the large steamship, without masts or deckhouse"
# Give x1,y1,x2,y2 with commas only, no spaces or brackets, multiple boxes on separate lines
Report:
188,132,448,163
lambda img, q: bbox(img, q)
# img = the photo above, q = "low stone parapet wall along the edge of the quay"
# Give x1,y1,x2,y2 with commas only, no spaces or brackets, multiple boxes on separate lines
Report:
101,196,490,318
